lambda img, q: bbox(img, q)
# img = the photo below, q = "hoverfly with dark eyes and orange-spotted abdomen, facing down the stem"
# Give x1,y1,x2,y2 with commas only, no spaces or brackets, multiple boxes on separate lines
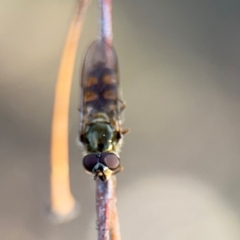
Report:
79,40,128,181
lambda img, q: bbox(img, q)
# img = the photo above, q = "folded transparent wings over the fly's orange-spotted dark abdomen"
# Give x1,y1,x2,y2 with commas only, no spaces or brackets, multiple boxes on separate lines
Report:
80,40,123,133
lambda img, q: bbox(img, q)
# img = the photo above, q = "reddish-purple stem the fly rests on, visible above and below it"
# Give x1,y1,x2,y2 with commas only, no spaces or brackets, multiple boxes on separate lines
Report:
96,0,121,237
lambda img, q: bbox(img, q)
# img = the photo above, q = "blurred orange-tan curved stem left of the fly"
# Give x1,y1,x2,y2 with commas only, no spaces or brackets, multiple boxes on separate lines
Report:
51,0,90,222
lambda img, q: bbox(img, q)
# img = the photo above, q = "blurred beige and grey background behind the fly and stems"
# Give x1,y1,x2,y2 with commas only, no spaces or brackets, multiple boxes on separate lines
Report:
0,0,240,240
